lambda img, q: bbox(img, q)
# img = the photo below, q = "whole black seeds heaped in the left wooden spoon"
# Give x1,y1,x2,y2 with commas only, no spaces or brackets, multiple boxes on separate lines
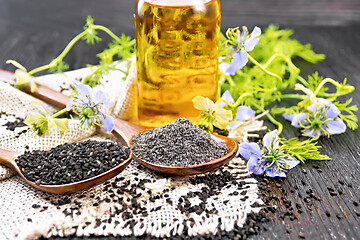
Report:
16,140,130,185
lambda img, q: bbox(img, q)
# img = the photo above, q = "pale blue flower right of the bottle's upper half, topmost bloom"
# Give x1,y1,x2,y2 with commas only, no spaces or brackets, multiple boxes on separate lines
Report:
219,27,261,76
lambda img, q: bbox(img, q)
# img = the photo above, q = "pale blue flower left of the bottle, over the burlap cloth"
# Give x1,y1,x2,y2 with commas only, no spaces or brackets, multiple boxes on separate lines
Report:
66,84,115,133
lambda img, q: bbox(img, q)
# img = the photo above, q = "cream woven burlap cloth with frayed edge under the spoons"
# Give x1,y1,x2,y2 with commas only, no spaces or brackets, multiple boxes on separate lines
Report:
0,62,262,239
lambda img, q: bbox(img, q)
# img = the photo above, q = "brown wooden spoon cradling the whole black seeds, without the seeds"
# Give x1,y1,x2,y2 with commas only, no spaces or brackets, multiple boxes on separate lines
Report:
0,149,133,194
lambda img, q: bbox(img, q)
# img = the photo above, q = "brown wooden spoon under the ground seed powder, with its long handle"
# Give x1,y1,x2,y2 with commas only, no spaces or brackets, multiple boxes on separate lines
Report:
0,71,238,175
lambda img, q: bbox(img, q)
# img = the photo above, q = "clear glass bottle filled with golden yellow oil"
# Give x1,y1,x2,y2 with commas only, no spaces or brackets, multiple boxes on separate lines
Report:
135,0,221,127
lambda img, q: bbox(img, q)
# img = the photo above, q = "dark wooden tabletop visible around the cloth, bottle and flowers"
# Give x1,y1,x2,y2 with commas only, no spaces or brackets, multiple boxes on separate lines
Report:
0,0,360,239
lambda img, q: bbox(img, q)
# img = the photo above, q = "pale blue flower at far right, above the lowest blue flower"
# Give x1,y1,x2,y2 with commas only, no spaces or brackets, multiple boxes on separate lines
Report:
283,98,346,138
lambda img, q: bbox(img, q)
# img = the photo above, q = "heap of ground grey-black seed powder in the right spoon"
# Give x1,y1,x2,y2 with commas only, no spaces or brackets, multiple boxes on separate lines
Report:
131,118,229,166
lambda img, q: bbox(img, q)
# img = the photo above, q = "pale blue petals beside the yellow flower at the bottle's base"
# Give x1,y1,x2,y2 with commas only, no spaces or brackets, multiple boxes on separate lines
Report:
218,90,255,130
